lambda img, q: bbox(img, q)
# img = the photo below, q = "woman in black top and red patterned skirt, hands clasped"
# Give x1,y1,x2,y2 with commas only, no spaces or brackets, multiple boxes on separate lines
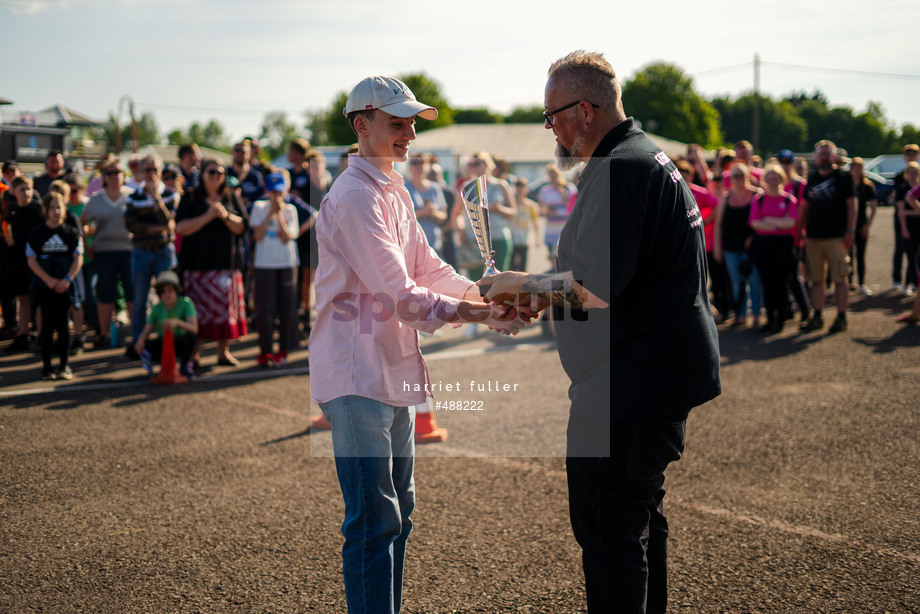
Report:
176,160,249,366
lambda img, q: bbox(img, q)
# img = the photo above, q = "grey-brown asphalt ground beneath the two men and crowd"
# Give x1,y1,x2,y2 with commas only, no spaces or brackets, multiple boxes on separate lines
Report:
0,208,920,614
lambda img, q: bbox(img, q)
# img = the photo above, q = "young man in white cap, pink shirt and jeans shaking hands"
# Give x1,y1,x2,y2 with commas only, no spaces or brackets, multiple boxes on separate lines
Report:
310,76,523,613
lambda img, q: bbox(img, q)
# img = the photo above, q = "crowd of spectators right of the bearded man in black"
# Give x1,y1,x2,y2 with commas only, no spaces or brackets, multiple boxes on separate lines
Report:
678,140,920,335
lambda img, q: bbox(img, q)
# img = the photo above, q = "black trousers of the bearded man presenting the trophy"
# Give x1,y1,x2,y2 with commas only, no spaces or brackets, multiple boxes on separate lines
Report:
566,412,686,614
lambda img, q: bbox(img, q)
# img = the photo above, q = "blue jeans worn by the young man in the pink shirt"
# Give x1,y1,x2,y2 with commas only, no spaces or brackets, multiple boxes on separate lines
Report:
320,395,415,614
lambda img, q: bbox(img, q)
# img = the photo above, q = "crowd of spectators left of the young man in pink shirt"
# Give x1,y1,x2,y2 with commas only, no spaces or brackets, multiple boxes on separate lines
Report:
0,139,327,379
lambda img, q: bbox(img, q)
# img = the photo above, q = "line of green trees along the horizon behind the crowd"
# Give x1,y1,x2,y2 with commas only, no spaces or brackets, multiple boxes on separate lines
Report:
97,62,920,158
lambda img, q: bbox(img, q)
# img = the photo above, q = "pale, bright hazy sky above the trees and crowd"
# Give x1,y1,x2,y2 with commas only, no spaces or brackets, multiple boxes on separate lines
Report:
0,0,920,151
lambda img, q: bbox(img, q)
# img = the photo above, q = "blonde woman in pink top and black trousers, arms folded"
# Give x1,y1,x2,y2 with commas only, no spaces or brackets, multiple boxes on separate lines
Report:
749,164,798,333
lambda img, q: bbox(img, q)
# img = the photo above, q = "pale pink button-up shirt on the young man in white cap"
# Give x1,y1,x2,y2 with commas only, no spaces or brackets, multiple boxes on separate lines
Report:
310,155,473,407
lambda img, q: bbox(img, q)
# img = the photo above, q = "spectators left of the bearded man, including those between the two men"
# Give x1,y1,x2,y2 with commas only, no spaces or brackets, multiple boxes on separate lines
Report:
0,138,576,379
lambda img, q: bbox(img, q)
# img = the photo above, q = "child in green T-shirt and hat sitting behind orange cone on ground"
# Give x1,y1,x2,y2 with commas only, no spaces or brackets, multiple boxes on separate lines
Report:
134,271,198,378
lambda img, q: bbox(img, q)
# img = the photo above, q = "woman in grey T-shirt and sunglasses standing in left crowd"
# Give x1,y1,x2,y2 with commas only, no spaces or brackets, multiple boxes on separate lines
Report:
80,158,134,350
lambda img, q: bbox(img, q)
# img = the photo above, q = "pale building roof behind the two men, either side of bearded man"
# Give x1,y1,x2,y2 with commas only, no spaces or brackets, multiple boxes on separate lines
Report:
412,123,687,162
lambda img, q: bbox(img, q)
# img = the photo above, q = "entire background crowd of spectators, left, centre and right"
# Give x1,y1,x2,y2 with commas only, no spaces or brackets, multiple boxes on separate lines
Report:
7,139,920,378
